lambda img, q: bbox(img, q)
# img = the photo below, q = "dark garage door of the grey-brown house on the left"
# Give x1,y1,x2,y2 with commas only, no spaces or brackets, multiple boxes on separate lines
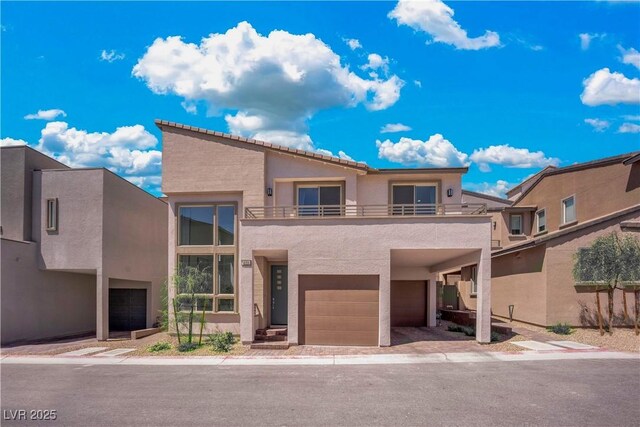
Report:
109,289,147,331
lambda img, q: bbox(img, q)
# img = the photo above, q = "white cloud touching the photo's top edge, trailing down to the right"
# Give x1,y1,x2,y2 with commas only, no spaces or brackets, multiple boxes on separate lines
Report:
388,0,500,50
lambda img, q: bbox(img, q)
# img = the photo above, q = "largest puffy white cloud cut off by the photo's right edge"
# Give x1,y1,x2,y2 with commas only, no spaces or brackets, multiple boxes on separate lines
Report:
580,68,640,107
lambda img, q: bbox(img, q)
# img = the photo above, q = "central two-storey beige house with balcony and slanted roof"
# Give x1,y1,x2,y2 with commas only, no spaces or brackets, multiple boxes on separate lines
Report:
156,121,491,346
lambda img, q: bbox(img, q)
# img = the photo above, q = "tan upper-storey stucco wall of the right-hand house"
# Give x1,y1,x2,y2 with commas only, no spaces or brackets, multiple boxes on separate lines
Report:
518,163,640,236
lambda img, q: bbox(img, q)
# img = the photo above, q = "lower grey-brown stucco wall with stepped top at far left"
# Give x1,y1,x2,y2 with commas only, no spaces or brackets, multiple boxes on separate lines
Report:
0,239,96,344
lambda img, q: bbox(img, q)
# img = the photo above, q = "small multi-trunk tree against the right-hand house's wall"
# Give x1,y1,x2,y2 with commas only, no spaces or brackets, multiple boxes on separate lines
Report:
573,232,640,335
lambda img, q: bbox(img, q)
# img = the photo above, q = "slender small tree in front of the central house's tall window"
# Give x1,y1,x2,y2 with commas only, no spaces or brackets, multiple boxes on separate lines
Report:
173,266,213,345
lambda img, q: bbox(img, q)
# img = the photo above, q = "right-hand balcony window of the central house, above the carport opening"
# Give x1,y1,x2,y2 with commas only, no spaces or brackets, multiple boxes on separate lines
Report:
391,183,438,215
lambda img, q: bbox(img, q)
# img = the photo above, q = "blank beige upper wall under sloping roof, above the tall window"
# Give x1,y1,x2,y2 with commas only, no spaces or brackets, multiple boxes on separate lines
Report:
162,129,265,206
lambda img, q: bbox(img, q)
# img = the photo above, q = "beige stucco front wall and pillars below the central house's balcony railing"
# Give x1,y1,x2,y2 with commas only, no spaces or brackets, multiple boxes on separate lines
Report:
239,217,491,345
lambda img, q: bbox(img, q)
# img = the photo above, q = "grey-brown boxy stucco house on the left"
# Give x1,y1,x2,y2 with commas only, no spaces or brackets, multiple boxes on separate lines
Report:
0,146,167,344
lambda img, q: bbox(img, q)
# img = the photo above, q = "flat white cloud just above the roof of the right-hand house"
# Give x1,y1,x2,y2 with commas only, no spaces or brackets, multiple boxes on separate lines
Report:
470,144,560,172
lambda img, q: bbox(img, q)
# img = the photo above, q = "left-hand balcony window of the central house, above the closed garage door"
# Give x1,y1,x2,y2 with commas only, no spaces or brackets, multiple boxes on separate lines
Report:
297,184,343,216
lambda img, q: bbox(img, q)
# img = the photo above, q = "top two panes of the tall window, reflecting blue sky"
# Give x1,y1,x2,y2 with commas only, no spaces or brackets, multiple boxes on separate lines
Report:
179,205,236,246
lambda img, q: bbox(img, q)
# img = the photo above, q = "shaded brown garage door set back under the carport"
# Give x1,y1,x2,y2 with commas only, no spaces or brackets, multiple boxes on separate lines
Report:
391,280,427,326
